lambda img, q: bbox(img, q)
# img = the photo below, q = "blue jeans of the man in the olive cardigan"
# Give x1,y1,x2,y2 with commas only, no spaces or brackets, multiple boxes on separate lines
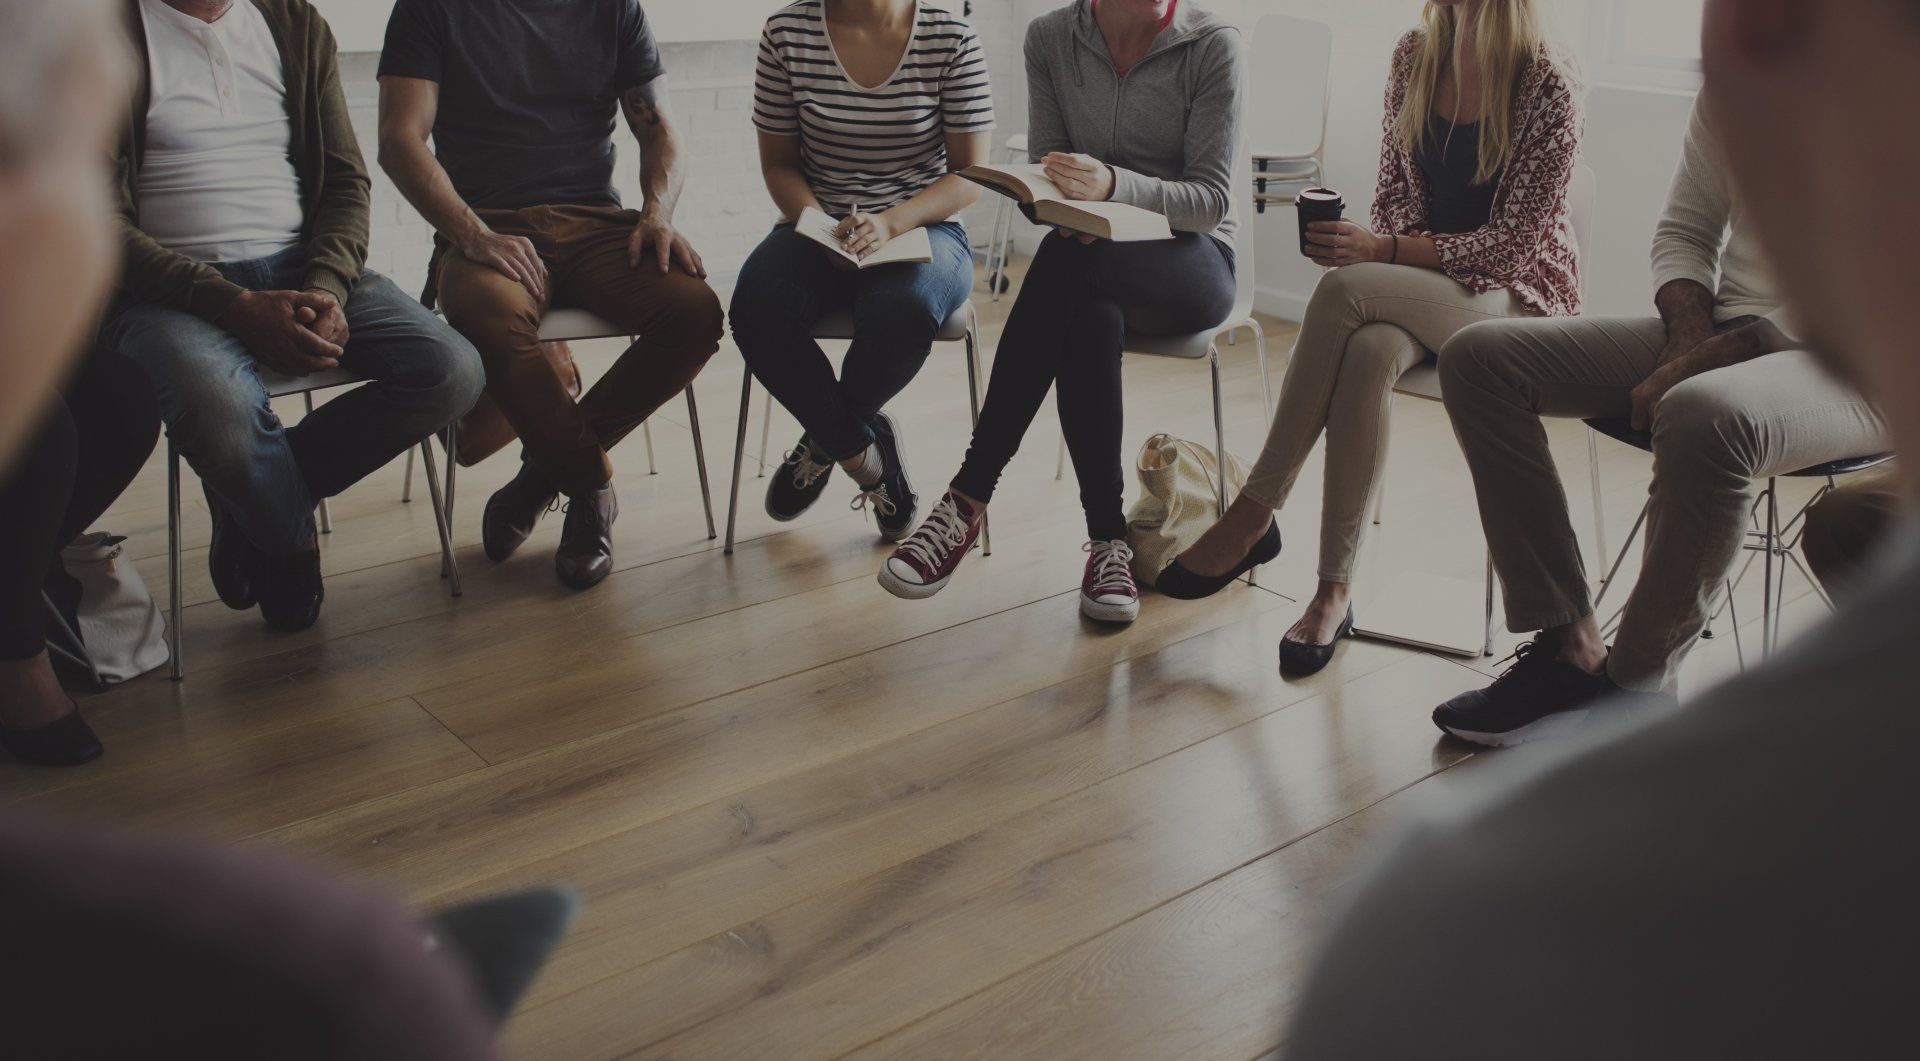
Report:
100,248,484,556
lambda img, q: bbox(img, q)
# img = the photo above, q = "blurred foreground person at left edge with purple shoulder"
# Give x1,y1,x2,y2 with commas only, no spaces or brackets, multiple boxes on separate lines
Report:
0,0,572,1061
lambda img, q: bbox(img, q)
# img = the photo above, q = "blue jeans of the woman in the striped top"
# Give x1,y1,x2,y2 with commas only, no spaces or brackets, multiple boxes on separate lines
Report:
728,221,973,460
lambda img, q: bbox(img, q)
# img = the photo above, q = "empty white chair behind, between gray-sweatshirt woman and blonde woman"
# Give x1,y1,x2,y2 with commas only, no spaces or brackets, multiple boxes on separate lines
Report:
1246,15,1332,213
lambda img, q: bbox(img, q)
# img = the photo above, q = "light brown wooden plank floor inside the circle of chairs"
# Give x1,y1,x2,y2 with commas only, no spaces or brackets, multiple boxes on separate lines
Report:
0,268,1818,1059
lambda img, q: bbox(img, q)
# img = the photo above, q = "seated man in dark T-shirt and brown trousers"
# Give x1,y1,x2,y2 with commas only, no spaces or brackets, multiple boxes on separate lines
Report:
380,0,720,589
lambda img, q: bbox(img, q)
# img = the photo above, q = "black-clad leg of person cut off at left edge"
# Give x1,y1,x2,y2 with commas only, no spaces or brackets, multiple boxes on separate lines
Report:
0,349,159,660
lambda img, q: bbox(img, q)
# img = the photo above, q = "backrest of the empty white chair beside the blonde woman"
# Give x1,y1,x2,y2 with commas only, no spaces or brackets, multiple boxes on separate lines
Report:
1246,15,1332,157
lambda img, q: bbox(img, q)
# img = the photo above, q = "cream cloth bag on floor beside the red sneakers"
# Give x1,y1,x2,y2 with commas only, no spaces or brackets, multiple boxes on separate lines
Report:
1127,436,1246,585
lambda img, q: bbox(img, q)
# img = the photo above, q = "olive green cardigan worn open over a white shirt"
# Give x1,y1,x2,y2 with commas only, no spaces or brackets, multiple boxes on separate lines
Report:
113,0,369,320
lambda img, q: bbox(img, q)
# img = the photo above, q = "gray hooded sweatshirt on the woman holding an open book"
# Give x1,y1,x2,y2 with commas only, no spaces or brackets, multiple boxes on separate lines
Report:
1027,0,1240,248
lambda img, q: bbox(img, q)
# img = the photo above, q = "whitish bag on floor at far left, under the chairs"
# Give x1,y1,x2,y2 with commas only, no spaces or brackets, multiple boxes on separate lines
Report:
60,533,167,683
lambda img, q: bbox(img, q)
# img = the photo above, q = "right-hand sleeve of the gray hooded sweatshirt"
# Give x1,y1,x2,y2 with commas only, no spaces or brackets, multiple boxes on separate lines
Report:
1110,31,1240,232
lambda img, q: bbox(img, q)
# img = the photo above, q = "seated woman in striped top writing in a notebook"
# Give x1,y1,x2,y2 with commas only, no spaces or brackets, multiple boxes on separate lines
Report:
730,0,993,541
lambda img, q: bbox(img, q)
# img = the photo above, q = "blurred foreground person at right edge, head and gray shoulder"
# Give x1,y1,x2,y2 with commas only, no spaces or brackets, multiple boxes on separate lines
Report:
1288,0,1920,1061
